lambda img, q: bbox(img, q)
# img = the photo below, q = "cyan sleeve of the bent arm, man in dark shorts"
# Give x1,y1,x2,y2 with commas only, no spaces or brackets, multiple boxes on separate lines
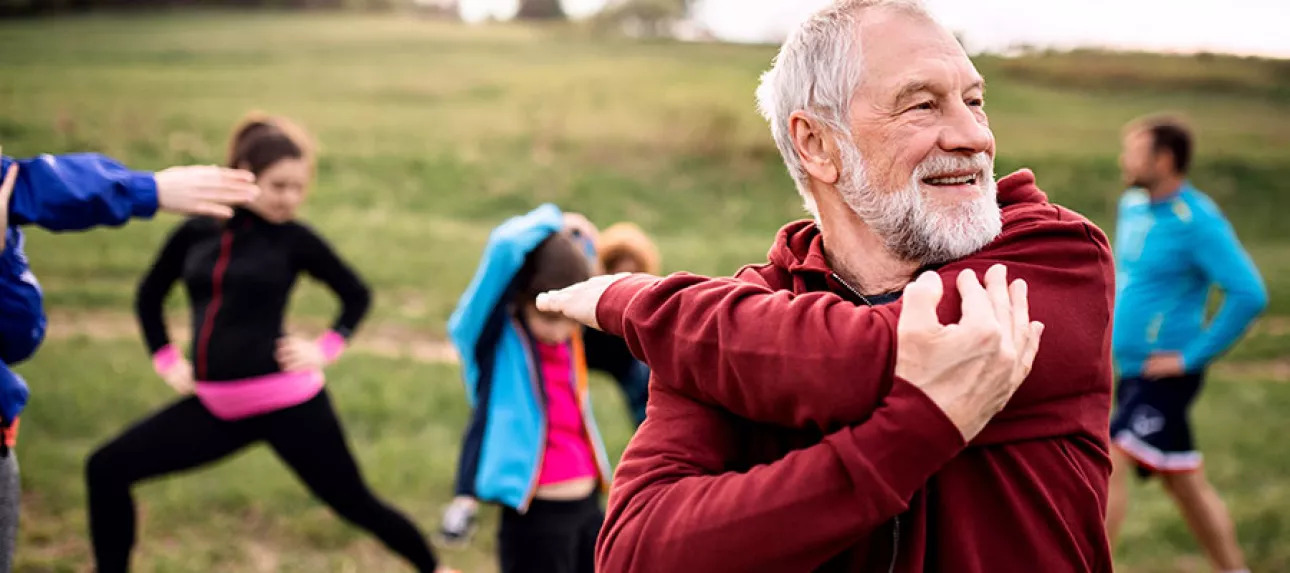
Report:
1183,214,1268,370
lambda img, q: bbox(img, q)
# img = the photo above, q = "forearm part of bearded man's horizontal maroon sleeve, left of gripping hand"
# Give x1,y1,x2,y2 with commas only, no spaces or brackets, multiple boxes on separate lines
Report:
597,274,899,428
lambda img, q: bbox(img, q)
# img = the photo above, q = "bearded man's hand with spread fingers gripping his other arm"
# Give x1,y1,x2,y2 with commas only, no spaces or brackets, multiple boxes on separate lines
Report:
895,265,1044,441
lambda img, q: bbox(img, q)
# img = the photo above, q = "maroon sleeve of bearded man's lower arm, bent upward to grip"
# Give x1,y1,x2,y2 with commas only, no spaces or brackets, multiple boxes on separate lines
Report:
596,379,964,573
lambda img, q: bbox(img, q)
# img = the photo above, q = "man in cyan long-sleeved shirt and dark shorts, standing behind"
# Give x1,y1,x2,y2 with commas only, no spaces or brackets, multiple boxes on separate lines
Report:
1107,117,1268,572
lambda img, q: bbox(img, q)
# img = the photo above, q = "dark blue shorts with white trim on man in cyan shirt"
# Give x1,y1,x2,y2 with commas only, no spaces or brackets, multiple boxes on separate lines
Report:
1111,372,1205,478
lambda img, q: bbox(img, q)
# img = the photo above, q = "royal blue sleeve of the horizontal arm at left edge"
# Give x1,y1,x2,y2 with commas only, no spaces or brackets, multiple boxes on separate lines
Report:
0,154,157,231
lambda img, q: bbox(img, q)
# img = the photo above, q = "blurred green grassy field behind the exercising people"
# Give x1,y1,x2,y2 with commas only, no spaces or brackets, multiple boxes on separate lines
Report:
0,14,1290,573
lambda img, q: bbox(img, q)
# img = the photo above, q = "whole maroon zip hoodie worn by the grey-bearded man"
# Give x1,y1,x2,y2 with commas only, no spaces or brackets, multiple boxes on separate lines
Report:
596,170,1115,573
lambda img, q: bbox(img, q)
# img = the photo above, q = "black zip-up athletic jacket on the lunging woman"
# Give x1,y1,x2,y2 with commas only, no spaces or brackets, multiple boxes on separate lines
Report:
135,209,372,381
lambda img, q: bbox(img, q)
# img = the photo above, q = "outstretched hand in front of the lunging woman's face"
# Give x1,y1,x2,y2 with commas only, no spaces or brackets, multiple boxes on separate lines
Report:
154,165,259,218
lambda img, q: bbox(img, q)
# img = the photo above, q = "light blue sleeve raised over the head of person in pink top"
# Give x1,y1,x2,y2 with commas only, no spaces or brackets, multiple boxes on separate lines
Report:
448,204,564,392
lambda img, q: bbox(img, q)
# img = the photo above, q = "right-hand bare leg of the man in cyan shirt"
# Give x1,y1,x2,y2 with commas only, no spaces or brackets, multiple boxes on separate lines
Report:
1161,468,1245,572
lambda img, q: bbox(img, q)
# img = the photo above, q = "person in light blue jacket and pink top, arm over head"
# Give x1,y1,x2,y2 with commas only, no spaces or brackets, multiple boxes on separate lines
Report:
444,204,609,573
